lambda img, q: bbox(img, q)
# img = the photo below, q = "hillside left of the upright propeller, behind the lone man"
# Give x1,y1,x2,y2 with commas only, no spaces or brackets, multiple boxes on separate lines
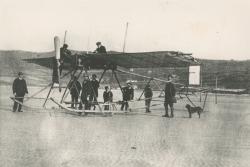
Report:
0,50,53,85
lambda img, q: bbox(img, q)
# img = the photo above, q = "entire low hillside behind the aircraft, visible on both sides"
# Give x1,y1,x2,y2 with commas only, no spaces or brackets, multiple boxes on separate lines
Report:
0,50,250,89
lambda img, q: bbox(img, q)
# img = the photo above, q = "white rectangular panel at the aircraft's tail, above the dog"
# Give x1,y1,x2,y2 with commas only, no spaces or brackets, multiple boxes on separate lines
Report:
188,66,201,85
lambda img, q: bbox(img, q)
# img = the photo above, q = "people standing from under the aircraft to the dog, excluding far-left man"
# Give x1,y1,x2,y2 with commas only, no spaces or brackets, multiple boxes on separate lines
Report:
69,74,176,115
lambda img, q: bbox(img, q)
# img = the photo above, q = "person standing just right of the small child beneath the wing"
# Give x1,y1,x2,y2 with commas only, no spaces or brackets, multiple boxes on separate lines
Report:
121,81,134,111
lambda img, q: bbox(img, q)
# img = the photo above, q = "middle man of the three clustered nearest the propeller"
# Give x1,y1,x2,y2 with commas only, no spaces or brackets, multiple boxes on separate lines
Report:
79,76,92,110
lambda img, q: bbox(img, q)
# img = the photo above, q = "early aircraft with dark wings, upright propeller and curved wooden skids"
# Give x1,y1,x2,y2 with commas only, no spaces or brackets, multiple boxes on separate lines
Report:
13,36,205,113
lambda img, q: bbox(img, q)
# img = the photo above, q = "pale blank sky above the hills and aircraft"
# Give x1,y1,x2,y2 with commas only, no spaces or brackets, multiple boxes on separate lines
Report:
0,0,250,59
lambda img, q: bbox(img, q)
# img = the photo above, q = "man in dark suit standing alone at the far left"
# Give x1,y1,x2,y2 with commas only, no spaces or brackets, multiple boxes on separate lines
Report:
12,72,28,112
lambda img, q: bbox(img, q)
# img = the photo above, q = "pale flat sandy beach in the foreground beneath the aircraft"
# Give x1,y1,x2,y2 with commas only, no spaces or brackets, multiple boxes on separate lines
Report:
0,86,250,167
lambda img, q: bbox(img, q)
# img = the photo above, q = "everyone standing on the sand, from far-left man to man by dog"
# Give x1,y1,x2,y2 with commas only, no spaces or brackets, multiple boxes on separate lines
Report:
12,72,176,117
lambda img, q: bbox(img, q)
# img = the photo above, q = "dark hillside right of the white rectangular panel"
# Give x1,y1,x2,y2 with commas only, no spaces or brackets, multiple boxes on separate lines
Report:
200,60,250,89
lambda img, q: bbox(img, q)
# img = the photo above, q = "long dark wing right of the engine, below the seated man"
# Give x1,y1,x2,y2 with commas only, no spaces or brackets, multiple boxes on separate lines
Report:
82,51,200,68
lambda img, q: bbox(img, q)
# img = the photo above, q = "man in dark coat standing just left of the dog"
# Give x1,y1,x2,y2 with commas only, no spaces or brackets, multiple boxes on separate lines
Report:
163,75,175,118
